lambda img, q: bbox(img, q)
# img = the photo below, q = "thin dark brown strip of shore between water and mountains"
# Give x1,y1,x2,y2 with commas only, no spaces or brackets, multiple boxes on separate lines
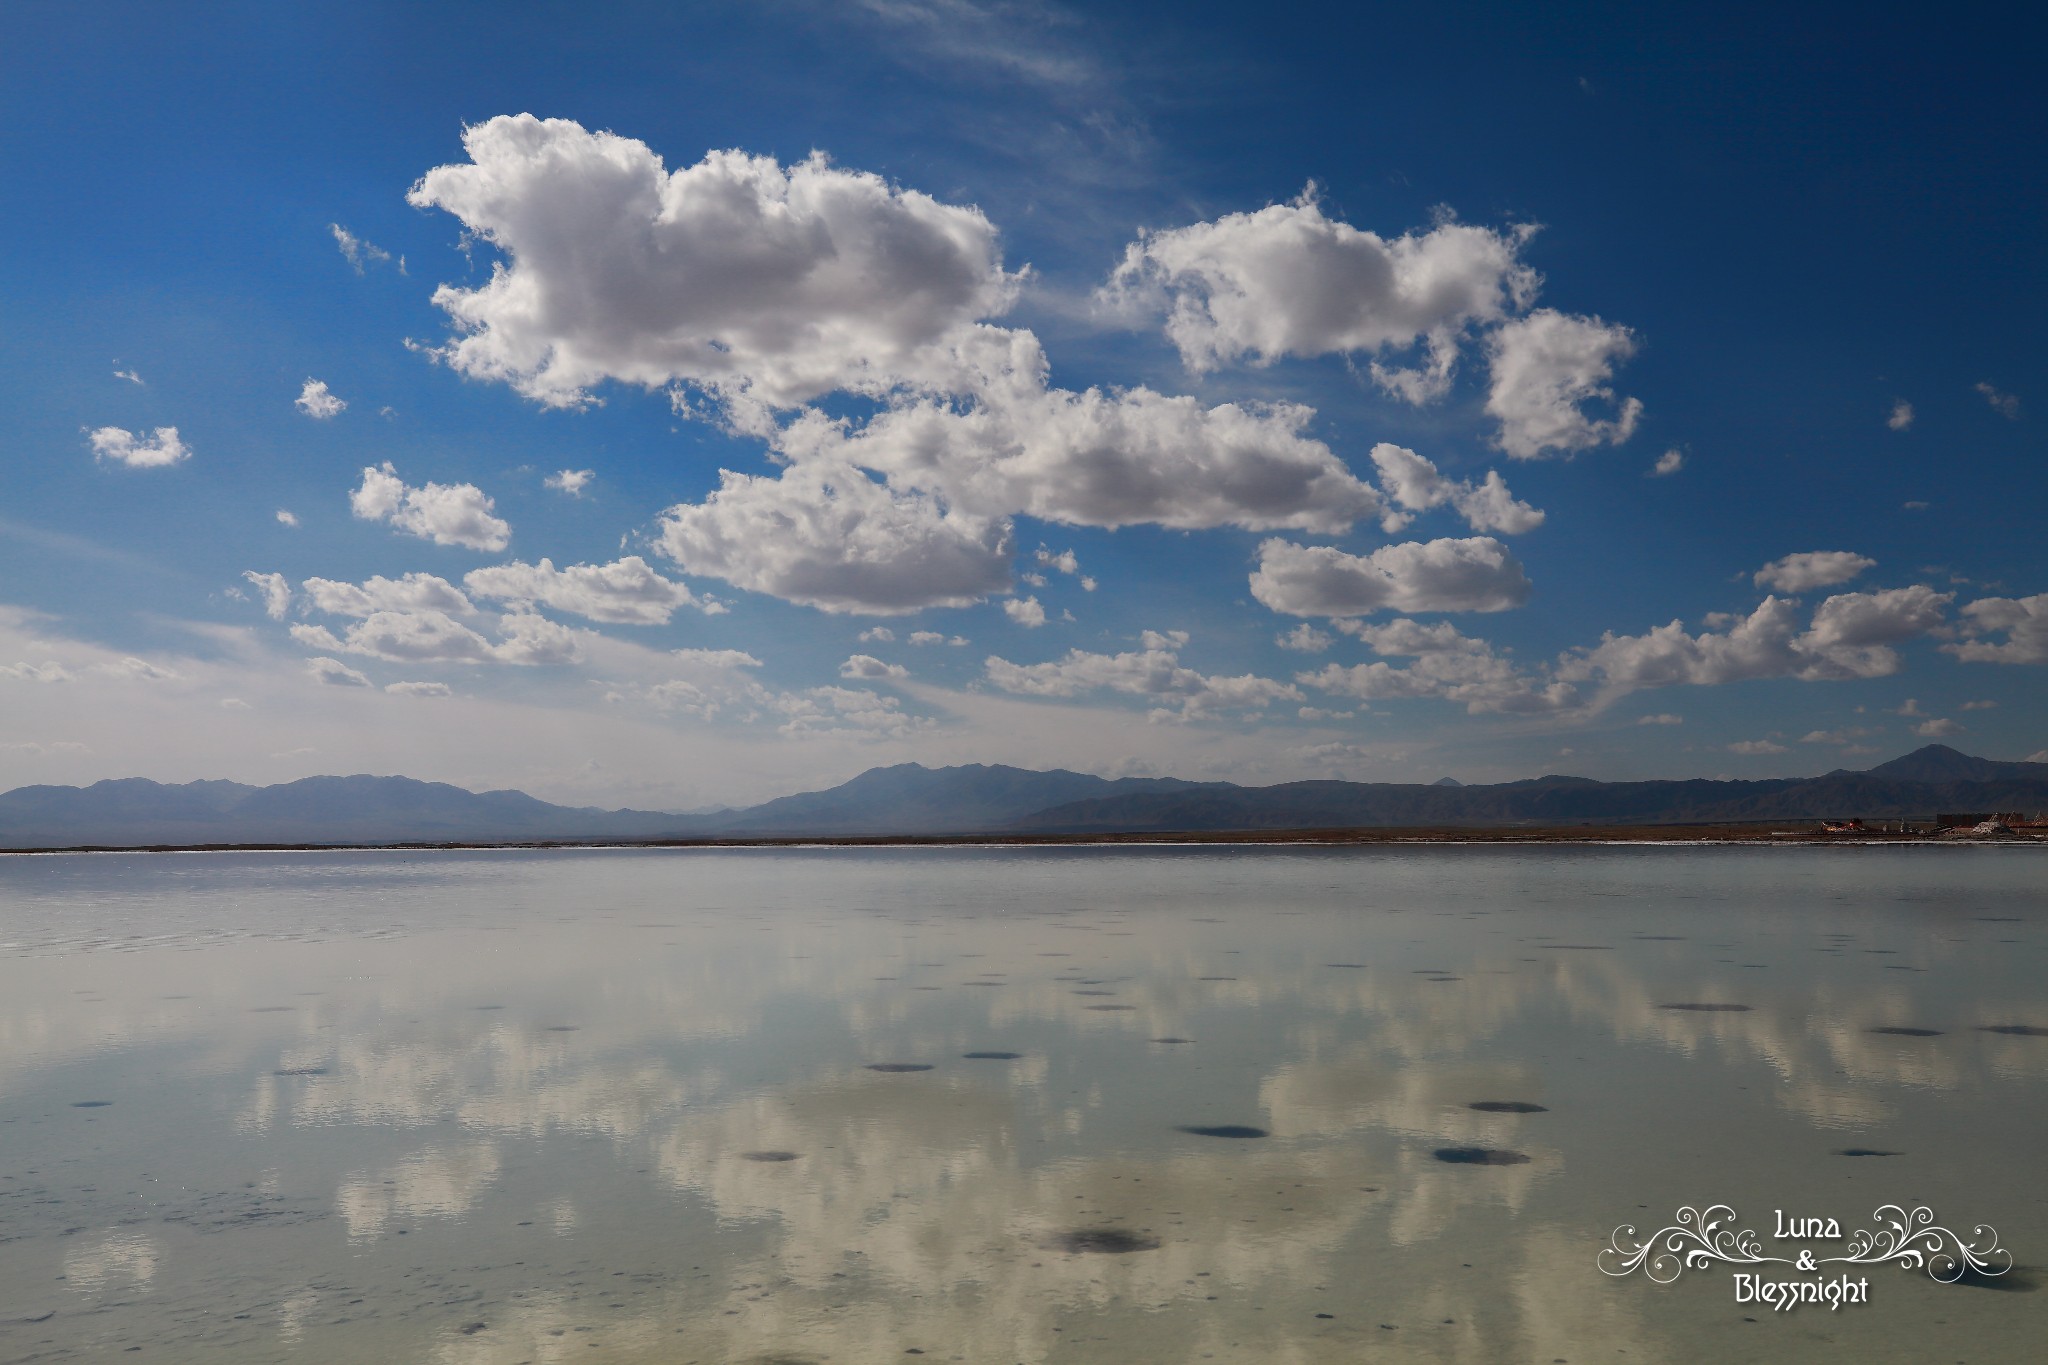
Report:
0,825,2048,855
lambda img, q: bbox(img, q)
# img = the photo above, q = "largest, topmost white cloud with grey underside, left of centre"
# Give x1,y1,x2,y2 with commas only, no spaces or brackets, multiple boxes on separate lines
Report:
408,115,1016,407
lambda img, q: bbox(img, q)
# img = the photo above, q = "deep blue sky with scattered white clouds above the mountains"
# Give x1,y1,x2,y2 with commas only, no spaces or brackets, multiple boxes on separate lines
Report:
0,0,2048,810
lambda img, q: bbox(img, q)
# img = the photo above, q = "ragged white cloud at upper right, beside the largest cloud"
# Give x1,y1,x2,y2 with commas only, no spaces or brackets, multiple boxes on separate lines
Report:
1100,184,1538,392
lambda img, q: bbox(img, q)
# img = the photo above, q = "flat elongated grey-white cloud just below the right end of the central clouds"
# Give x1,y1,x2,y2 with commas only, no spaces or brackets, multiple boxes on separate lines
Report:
1251,536,1530,616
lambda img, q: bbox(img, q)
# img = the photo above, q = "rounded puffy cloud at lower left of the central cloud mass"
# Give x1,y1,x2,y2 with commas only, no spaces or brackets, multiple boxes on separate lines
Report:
662,463,1010,616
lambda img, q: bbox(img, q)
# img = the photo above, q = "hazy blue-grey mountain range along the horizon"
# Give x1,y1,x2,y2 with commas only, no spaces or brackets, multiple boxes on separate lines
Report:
0,745,2048,849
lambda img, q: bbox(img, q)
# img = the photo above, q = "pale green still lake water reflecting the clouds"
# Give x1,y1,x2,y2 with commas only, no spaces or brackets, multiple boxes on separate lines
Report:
0,847,2048,1365
